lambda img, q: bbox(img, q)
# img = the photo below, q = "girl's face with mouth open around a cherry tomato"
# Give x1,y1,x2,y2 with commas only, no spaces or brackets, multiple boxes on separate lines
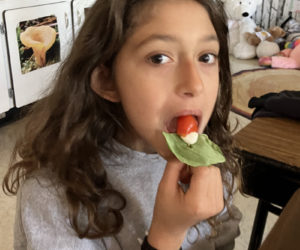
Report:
114,0,219,159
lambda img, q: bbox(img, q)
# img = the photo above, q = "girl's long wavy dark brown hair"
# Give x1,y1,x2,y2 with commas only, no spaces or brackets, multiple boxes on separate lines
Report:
3,0,238,238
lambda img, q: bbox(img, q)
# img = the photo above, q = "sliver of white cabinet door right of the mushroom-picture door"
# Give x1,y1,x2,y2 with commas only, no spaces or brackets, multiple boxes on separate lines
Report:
72,0,96,35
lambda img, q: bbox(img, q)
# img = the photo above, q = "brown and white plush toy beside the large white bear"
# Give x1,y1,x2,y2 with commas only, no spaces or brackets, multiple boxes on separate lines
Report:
245,26,286,58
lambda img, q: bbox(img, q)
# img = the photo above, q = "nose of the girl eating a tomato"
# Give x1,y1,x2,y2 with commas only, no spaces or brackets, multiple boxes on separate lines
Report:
176,61,203,97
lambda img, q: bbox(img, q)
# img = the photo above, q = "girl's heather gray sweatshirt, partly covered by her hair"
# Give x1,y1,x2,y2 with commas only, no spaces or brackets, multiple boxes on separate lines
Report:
14,143,241,250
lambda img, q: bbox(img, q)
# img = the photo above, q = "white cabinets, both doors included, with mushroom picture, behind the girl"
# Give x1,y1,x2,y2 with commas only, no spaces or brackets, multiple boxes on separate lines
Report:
0,0,96,117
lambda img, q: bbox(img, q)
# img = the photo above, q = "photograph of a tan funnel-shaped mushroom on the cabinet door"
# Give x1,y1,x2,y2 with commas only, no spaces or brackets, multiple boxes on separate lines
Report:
17,16,60,74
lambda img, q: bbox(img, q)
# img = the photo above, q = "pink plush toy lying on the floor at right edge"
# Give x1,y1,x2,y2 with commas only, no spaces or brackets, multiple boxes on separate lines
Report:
258,39,300,69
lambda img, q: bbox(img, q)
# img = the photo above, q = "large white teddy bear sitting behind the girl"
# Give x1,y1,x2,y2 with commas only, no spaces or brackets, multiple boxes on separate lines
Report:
222,0,262,59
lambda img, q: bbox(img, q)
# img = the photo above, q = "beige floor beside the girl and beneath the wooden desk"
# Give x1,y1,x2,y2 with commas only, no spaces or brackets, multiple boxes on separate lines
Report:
0,113,277,250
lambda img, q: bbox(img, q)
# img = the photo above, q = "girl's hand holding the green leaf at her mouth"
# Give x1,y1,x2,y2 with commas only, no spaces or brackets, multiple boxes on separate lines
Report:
148,160,224,250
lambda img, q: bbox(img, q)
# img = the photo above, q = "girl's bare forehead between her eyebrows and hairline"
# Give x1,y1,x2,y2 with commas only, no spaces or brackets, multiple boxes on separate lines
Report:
127,0,216,43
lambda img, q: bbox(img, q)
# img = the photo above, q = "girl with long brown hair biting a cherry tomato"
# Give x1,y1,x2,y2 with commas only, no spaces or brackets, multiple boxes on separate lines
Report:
4,0,240,250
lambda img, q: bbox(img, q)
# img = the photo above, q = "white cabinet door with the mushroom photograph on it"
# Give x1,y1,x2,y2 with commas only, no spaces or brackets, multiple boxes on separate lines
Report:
4,2,72,107
